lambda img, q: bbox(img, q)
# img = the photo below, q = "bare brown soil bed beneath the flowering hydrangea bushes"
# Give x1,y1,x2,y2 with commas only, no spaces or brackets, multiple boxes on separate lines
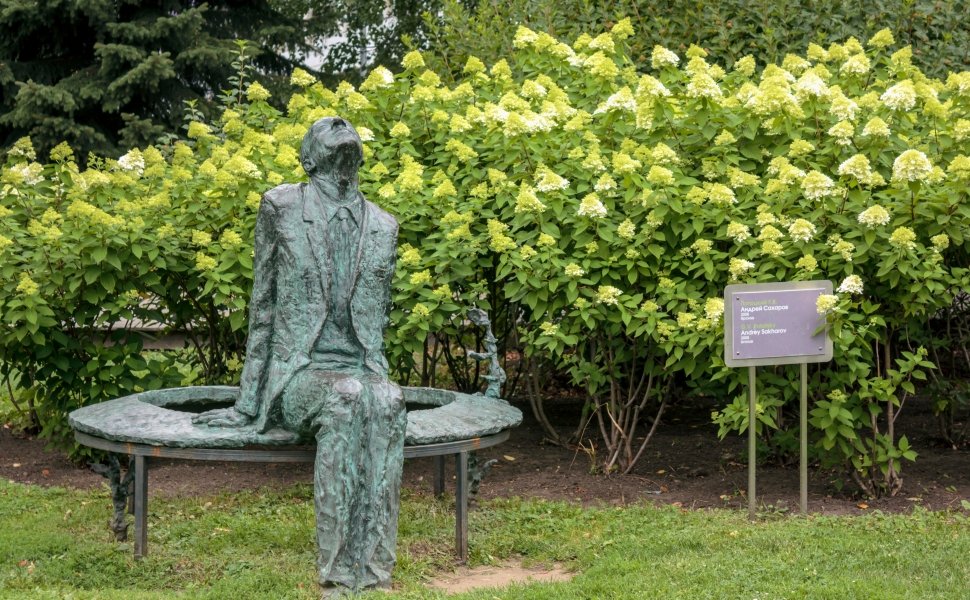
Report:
0,394,970,514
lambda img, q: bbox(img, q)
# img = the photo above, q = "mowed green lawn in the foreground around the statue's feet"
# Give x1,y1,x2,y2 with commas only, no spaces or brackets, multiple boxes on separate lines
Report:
0,482,970,600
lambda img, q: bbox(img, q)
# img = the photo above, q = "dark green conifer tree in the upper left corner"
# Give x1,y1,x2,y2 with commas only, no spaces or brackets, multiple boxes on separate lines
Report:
0,0,309,157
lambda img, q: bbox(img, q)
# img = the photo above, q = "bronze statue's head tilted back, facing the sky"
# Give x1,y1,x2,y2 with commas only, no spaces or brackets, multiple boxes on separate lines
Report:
300,117,364,182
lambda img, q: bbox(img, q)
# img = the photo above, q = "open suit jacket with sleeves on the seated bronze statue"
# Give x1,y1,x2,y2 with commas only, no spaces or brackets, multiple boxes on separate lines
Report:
235,184,397,432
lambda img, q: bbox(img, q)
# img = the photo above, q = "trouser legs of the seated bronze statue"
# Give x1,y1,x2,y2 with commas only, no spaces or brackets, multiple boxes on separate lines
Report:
280,365,407,590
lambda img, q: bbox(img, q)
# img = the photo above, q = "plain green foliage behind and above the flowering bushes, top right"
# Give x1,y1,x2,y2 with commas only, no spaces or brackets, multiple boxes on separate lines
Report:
426,0,970,77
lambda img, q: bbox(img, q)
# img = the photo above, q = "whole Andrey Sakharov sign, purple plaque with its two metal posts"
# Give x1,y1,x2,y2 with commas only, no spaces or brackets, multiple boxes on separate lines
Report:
724,281,832,519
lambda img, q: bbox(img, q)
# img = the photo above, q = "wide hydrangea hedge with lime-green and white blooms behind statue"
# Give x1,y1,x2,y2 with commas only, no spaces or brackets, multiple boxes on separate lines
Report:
0,20,970,494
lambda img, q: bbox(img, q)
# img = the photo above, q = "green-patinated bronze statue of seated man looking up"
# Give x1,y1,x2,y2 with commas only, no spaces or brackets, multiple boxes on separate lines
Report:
193,117,406,591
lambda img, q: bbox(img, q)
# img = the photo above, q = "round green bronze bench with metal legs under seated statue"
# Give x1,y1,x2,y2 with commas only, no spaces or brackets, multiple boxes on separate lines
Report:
68,386,522,560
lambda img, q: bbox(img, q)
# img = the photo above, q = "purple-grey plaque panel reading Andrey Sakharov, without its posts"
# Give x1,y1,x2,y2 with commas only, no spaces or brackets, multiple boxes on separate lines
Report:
724,281,832,367
